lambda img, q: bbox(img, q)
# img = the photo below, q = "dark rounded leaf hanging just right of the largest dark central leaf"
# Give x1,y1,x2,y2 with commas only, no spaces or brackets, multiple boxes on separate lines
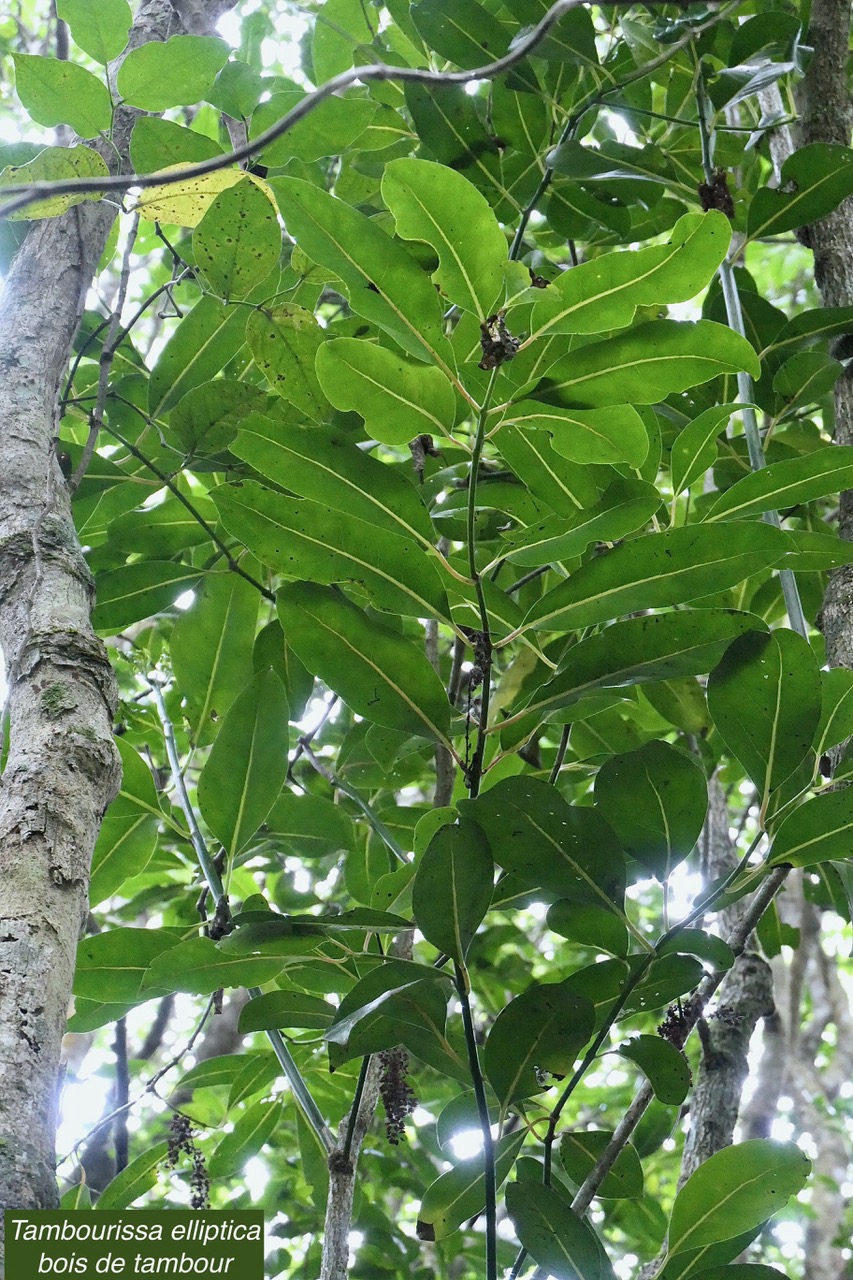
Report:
596,741,708,881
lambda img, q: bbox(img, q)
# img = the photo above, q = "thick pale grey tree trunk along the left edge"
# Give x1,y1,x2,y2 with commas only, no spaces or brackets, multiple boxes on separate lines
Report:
0,0,229,1231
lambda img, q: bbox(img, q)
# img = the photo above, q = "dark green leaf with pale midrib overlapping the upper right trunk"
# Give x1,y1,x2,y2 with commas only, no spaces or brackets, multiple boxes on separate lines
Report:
747,142,853,239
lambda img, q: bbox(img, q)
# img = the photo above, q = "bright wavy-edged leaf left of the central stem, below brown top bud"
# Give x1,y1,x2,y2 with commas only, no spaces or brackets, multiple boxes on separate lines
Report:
316,338,456,445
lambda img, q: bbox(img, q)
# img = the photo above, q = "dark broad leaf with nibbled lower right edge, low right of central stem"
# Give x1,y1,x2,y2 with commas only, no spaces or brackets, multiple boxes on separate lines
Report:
483,979,594,1112
